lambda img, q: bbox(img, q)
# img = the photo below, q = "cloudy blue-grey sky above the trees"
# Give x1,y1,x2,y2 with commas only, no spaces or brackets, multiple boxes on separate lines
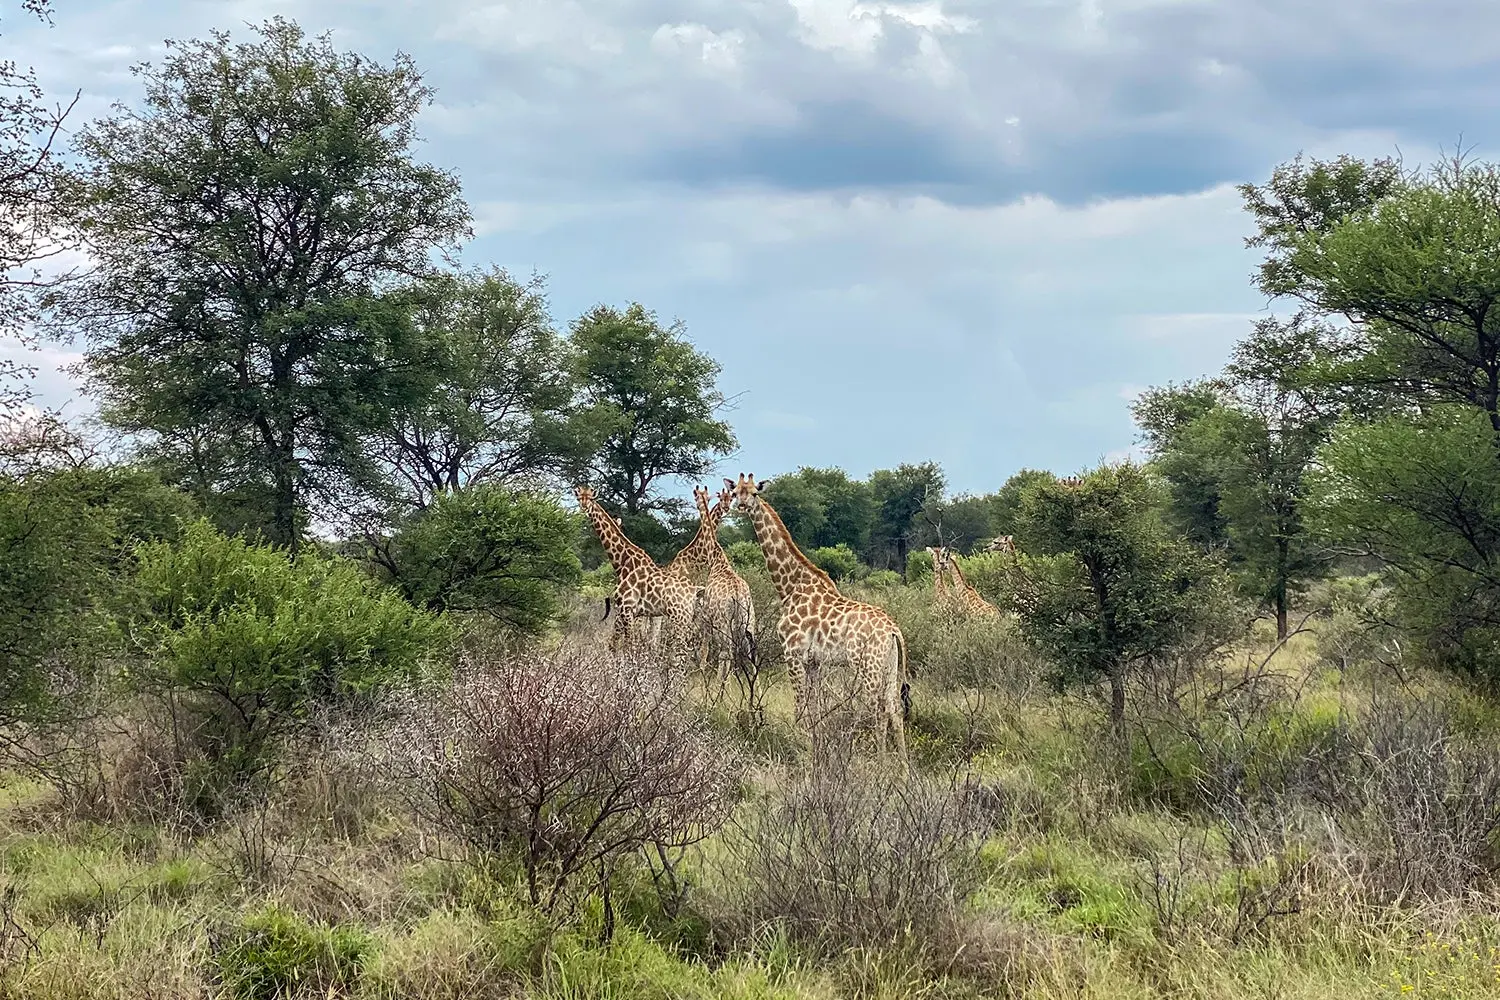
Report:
0,0,1500,493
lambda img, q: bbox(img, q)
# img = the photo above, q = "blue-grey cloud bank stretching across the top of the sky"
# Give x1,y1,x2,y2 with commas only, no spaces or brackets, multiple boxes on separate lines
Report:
17,0,1500,202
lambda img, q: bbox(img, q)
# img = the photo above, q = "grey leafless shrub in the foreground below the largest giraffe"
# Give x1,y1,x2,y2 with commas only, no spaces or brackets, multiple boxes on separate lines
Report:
720,741,989,964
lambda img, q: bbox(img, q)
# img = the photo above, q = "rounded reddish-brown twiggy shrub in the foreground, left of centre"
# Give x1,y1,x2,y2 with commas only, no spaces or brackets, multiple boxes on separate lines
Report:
383,643,743,934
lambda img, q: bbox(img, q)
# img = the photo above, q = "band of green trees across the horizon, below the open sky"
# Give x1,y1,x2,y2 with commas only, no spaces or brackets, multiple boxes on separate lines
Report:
0,13,1500,710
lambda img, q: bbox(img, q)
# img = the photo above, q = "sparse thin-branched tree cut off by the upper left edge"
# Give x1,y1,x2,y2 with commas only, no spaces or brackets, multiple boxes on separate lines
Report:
0,0,78,412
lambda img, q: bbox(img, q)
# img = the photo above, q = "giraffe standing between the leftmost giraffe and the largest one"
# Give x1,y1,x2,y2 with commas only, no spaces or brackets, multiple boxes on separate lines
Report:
666,486,755,697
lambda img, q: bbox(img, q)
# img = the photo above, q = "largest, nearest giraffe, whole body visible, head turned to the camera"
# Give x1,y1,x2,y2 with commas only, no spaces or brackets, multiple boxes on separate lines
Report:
725,472,911,760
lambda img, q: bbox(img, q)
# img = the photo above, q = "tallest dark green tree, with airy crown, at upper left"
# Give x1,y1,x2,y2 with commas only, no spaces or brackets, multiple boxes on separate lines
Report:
53,18,468,549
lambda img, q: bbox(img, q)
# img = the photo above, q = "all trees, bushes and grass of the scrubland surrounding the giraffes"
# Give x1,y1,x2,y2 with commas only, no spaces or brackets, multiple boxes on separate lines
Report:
0,3,1500,1000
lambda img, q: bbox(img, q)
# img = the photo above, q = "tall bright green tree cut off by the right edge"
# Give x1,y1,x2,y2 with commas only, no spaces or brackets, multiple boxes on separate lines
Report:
1238,157,1500,676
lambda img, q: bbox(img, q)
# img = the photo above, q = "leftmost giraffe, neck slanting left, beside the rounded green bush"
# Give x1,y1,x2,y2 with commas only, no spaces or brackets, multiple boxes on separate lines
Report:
575,486,704,667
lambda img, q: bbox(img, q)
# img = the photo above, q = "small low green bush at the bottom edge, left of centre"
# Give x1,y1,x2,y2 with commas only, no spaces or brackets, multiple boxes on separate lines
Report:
213,906,375,1000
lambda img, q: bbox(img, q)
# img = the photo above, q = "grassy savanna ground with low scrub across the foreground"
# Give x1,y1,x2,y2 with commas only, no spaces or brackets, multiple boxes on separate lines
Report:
0,573,1500,1000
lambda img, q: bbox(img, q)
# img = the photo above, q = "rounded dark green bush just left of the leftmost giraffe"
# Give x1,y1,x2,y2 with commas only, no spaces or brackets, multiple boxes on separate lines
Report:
368,486,579,634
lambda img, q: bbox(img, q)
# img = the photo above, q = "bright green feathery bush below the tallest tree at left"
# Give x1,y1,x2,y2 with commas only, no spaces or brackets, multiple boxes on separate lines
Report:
131,520,450,799
